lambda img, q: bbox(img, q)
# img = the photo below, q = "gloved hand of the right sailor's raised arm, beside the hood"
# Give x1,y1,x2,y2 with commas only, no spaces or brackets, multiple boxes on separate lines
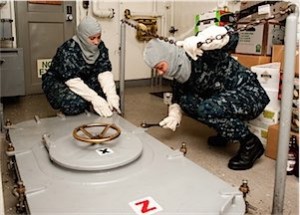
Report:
176,36,203,60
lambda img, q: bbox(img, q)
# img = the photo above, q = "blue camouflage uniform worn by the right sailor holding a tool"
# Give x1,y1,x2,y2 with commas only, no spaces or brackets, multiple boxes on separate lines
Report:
172,34,270,140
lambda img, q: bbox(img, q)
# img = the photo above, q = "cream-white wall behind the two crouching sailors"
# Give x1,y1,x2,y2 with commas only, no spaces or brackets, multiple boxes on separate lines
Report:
0,0,299,80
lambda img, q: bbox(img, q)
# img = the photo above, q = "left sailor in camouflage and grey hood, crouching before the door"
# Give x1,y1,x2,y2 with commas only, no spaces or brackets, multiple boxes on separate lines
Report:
42,16,120,117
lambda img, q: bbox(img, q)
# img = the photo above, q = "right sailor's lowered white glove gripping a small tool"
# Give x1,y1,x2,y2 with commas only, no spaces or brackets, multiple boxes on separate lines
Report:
159,103,182,131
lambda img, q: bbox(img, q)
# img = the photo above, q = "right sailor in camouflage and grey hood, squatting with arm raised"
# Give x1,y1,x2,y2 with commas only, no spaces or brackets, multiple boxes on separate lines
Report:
144,26,269,170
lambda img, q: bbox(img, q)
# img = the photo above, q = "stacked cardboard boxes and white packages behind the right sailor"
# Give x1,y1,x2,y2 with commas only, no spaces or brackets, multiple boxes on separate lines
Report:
232,1,299,159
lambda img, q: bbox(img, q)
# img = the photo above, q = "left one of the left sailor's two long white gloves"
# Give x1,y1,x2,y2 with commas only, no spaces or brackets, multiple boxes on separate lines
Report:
65,78,113,117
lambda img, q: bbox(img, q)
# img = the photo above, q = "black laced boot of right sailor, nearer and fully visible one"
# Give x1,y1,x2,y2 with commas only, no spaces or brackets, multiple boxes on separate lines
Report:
228,133,265,170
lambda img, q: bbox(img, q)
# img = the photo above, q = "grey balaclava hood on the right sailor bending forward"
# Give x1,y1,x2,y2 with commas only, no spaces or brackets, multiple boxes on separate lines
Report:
144,39,191,83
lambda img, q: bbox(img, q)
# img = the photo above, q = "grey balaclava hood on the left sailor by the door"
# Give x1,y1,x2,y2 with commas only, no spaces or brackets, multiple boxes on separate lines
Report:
73,16,101,64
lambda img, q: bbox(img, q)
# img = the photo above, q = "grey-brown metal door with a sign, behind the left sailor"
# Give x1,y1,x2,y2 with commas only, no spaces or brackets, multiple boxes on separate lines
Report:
15,0,76,95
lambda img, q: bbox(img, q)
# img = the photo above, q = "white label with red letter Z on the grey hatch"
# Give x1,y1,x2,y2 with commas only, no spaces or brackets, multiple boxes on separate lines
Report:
129,196,163,215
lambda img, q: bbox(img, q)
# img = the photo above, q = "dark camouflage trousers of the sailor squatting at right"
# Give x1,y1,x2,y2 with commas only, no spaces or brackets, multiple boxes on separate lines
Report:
180,88,268,140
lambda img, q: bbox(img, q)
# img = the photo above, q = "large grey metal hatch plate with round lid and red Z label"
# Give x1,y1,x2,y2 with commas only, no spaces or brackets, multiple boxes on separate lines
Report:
10,114,245,214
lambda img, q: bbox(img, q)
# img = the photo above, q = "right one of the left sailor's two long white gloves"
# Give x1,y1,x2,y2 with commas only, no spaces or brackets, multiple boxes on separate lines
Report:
98,71,121,114
